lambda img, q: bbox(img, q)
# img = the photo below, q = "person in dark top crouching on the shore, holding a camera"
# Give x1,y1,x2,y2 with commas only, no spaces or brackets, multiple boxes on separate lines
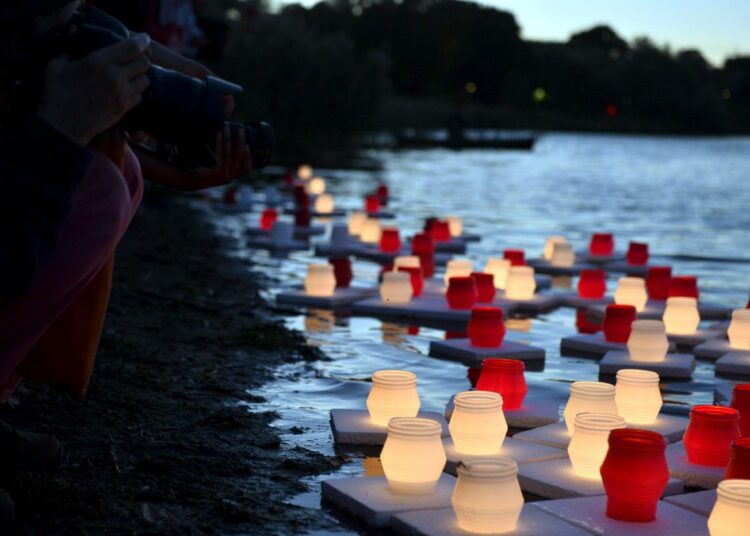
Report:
0,0,250,526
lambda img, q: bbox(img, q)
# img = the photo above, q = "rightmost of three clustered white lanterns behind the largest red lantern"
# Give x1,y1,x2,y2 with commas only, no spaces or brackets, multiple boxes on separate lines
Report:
615,369,662,424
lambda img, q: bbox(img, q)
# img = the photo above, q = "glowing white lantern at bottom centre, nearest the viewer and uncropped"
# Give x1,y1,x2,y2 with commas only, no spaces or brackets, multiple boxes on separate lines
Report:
451,456,524,534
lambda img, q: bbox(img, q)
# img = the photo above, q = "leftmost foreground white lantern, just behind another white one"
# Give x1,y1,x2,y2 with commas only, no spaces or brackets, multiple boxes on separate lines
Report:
367,370,420,426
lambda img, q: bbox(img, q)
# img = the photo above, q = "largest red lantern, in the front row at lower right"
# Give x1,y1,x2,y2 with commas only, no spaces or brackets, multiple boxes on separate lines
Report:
599,428,669,523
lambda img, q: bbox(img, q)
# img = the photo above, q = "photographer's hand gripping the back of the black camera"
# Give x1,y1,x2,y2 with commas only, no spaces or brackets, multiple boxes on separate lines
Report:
37,34,150,146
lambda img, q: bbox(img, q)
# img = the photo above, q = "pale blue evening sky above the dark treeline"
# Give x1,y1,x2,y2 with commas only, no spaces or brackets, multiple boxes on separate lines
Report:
277,0,750,65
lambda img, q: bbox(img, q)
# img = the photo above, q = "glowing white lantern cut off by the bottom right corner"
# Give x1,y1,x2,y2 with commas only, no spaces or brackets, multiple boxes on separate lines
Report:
708,479,750,536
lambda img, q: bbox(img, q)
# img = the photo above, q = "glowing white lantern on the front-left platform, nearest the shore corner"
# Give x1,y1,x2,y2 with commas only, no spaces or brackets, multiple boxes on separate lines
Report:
380,417,446,495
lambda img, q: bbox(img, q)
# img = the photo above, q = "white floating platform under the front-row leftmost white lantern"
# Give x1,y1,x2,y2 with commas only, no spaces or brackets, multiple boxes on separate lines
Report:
321,473,456,527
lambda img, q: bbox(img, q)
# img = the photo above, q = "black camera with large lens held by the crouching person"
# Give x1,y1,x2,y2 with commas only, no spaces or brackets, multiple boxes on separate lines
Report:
51,8,274,169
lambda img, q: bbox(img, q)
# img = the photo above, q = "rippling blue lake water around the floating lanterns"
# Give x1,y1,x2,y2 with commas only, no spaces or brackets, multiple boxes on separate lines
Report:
210,135,750,531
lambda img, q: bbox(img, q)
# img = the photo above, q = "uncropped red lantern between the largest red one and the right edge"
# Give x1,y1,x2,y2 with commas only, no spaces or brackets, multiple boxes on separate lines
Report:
682,406,740,467
